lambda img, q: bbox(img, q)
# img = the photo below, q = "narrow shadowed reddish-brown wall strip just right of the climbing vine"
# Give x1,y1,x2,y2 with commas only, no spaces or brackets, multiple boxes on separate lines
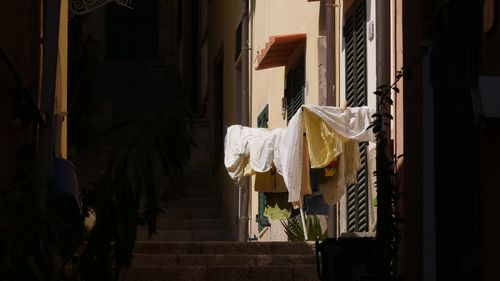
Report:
401,1,424,276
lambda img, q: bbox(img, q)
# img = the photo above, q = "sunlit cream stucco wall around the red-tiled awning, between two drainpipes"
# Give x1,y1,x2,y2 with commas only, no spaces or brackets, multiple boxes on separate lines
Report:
249,0,320,238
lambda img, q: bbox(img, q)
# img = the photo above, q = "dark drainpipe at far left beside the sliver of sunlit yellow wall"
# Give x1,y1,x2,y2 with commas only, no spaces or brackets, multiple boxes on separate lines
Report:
35,0,61,213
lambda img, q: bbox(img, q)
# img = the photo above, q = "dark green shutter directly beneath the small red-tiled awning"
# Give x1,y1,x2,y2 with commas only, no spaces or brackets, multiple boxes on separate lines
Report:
285,60,305,122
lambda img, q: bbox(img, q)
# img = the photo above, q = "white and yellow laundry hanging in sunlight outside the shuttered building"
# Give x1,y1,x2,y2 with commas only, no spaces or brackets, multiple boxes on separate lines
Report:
224,105,375,205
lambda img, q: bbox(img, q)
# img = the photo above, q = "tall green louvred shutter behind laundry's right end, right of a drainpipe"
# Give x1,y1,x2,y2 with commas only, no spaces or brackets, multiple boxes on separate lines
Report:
344,0,369,232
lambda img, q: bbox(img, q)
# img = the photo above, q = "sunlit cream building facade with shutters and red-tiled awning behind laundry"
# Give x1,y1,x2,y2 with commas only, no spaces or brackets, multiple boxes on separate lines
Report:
205,0,376,240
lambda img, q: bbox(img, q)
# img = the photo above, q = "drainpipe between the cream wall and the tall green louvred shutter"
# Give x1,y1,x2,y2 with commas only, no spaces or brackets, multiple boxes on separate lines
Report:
325,0,338,238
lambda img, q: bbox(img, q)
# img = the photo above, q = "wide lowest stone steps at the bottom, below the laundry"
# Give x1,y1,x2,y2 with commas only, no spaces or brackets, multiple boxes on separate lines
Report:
121,241,317,281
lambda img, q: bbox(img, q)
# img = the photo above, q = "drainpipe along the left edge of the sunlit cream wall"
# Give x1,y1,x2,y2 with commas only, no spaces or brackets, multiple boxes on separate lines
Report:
238,0,250,241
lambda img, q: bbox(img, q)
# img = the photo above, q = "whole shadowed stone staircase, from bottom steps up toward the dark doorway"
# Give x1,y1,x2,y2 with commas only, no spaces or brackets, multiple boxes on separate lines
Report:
72,61,318,281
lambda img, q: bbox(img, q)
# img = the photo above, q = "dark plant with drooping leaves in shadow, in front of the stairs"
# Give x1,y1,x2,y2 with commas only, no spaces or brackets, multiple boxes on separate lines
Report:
81,104,193,280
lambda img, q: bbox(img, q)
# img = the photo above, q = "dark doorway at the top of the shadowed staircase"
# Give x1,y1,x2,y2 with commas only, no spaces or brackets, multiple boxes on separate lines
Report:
106,0,158,60
